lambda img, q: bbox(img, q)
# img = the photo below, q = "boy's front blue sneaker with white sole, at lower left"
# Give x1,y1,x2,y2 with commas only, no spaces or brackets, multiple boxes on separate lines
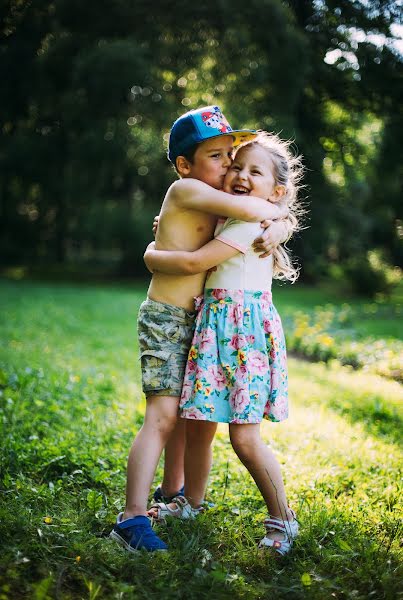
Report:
109,513,168,552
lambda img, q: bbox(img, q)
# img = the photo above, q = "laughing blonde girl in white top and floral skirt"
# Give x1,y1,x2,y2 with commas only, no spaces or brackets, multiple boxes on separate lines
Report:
144,131,302,555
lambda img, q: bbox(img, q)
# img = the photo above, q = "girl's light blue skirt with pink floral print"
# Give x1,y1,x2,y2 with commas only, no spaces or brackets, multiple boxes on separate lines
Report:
180,289,288,423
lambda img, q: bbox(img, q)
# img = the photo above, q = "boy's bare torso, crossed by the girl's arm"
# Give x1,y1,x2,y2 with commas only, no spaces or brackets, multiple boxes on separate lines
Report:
148,191,217,311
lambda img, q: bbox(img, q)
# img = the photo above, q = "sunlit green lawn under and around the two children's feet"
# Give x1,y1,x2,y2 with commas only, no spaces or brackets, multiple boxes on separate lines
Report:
0,281,402,600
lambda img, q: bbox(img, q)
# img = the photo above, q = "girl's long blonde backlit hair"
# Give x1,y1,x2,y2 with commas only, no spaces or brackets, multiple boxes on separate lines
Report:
237,131,306,283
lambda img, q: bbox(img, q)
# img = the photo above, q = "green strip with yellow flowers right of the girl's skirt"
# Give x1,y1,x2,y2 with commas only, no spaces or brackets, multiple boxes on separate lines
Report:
274,286,403,382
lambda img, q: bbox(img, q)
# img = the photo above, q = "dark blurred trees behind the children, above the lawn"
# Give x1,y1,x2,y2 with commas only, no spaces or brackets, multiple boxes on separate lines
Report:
0,0,403,295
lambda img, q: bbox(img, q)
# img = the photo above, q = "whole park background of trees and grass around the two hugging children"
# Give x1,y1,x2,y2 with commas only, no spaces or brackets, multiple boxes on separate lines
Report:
0,0,403,600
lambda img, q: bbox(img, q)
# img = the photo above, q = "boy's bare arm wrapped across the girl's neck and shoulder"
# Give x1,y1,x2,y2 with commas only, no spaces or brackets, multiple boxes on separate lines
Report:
170,178,289,222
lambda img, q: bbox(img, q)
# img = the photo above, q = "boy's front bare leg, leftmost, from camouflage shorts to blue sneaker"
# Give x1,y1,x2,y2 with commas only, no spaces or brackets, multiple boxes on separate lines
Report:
123,395,179,519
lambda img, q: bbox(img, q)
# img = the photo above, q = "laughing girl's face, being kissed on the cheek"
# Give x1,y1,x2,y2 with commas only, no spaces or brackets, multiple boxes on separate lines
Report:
223,145,279,201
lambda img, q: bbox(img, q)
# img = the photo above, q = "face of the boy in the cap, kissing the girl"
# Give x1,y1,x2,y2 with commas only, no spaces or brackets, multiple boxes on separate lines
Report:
186,135,234,190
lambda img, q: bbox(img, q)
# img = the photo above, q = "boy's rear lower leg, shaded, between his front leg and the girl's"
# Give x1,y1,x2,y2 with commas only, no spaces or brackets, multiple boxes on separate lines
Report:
161,419,186,496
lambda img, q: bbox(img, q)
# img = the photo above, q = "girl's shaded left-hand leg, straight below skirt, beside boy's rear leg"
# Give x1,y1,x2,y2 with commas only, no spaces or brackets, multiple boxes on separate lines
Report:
182,419,218,508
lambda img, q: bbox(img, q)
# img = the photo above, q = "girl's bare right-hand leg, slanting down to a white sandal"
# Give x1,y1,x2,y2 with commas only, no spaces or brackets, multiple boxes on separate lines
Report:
229,423,293,521
